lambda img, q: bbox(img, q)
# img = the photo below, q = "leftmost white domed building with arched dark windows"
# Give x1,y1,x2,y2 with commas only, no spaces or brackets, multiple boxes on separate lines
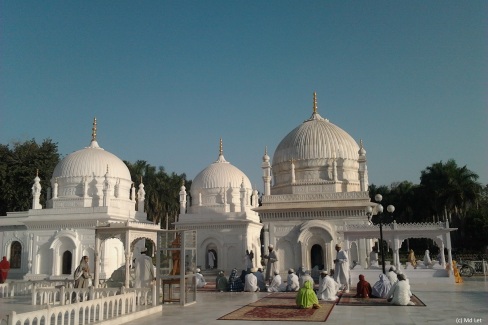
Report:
0,119,159,280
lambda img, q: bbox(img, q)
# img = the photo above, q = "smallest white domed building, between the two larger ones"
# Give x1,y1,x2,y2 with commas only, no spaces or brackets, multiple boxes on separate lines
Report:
175,139,262,275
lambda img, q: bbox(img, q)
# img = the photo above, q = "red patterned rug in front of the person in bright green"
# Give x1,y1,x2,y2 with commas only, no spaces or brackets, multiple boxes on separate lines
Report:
219,292,335,322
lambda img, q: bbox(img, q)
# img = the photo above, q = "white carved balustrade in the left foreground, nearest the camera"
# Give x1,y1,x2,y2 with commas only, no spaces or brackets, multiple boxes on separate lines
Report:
8,292,136,325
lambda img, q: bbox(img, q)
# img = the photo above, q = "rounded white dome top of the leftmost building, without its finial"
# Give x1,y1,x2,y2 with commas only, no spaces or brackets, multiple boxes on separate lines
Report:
53,140,131,180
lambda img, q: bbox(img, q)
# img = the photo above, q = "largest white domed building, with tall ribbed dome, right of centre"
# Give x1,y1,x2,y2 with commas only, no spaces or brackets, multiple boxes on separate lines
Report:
254,93,372,273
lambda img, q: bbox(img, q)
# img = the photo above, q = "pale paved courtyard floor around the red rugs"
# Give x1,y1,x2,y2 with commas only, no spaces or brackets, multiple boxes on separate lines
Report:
125,277,488,325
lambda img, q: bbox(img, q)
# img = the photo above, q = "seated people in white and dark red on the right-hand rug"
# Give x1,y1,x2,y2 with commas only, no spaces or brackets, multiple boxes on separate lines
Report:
355,266,415,306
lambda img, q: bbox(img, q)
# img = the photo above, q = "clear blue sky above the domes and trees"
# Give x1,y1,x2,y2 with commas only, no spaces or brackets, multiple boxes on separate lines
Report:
0,0,488,191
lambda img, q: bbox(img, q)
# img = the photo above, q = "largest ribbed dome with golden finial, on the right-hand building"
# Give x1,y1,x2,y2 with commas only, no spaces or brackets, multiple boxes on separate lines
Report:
271,93,365,194
